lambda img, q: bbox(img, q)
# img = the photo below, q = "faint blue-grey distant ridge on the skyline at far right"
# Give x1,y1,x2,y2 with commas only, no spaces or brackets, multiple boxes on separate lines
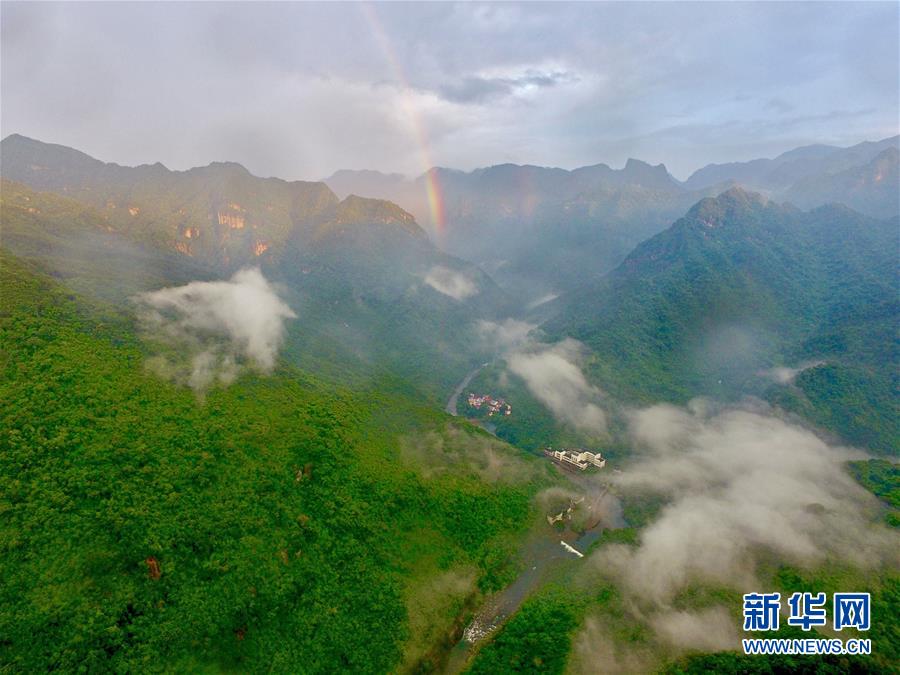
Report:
684,136,900,205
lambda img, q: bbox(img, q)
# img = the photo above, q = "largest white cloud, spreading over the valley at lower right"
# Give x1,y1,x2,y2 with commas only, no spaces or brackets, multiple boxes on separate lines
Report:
593,400,900,649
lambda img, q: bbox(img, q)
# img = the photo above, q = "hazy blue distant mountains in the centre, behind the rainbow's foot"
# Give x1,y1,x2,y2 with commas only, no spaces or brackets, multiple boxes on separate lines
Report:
326,159,712,304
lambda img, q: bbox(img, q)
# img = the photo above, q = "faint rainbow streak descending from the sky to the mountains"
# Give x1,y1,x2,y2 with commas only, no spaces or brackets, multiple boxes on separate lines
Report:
359,2,447,240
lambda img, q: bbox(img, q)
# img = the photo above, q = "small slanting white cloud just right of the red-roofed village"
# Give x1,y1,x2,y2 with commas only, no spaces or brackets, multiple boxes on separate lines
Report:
506,339,606,434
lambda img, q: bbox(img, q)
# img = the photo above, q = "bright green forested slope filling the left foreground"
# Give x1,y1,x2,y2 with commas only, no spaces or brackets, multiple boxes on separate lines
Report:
0,253,543,672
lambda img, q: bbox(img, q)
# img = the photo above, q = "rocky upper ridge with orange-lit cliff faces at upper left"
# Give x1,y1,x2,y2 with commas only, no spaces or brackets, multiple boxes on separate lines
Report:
2,135,425,269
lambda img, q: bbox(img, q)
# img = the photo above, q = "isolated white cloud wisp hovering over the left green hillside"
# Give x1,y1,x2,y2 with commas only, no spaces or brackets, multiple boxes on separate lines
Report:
135,268,296,391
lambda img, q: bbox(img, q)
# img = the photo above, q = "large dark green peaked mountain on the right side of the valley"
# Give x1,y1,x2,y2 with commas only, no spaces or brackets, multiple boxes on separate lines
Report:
544,188,900,452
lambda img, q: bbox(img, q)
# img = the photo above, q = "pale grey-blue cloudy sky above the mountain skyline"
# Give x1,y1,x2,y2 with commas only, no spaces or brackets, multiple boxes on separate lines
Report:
0,1,900,179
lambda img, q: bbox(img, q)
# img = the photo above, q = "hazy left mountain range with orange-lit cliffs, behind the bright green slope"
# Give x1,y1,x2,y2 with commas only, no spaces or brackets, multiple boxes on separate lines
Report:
0,136,509,400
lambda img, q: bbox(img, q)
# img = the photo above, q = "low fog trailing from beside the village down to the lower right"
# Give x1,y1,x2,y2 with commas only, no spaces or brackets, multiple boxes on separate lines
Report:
478,322,900,670
